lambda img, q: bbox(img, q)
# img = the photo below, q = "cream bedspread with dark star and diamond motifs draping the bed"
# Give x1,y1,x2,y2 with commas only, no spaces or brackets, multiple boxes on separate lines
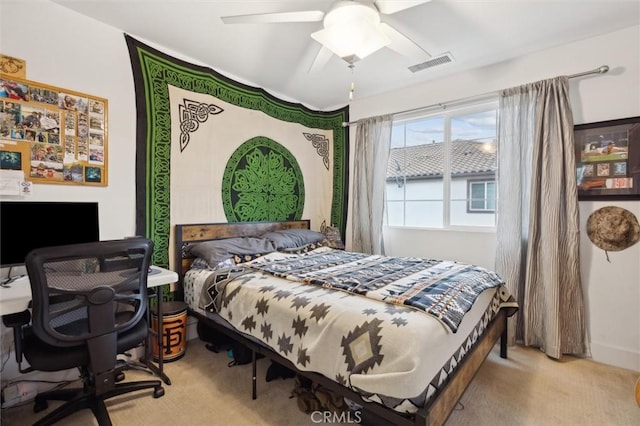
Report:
184,248,513,413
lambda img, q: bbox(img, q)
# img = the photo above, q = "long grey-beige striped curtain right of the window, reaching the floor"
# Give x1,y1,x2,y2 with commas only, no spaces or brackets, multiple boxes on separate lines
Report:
496,77,590,359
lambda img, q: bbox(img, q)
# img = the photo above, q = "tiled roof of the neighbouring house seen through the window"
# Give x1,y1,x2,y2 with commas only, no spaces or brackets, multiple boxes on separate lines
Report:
387,140,497,179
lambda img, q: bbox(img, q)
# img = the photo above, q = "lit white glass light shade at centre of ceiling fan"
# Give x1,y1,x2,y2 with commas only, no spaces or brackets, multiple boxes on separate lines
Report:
311,1,391,59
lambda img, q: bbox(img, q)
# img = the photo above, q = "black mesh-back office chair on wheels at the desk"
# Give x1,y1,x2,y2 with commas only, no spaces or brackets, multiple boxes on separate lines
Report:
3,238,164,426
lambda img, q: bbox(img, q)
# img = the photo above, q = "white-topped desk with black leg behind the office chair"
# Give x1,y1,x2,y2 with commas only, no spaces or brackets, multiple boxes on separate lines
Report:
0,266,178,385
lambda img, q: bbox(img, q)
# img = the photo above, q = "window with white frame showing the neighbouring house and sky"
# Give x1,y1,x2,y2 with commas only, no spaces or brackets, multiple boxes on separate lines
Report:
386,101,498,228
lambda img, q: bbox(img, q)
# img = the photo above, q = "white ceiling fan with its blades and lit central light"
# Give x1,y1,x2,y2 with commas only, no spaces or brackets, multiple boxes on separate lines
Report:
221,0,431,72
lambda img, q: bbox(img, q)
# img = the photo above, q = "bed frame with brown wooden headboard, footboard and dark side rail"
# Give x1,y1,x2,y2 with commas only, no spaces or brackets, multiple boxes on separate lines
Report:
175,220,507,426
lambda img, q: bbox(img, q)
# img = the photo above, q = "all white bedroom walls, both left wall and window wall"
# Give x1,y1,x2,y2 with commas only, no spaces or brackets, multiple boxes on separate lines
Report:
0,1,640,379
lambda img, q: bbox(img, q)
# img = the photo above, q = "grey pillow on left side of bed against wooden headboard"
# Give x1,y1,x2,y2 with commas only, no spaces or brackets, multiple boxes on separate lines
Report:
186,237,276,266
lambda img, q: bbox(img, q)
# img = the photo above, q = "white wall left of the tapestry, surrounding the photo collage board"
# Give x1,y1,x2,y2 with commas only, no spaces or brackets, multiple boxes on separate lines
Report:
0,2,136,239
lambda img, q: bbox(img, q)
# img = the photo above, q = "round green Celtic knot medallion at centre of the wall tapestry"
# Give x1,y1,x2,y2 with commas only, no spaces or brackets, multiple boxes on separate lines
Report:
222,136,305,222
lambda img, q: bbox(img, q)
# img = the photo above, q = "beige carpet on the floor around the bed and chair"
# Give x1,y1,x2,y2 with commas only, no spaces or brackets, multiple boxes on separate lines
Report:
0,340,640,426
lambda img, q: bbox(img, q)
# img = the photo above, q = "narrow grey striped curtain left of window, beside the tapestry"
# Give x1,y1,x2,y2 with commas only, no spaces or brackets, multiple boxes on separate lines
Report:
351,115,393,255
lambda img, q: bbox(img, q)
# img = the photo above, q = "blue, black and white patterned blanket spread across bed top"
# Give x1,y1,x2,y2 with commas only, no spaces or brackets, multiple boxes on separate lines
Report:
251,247,504,333
